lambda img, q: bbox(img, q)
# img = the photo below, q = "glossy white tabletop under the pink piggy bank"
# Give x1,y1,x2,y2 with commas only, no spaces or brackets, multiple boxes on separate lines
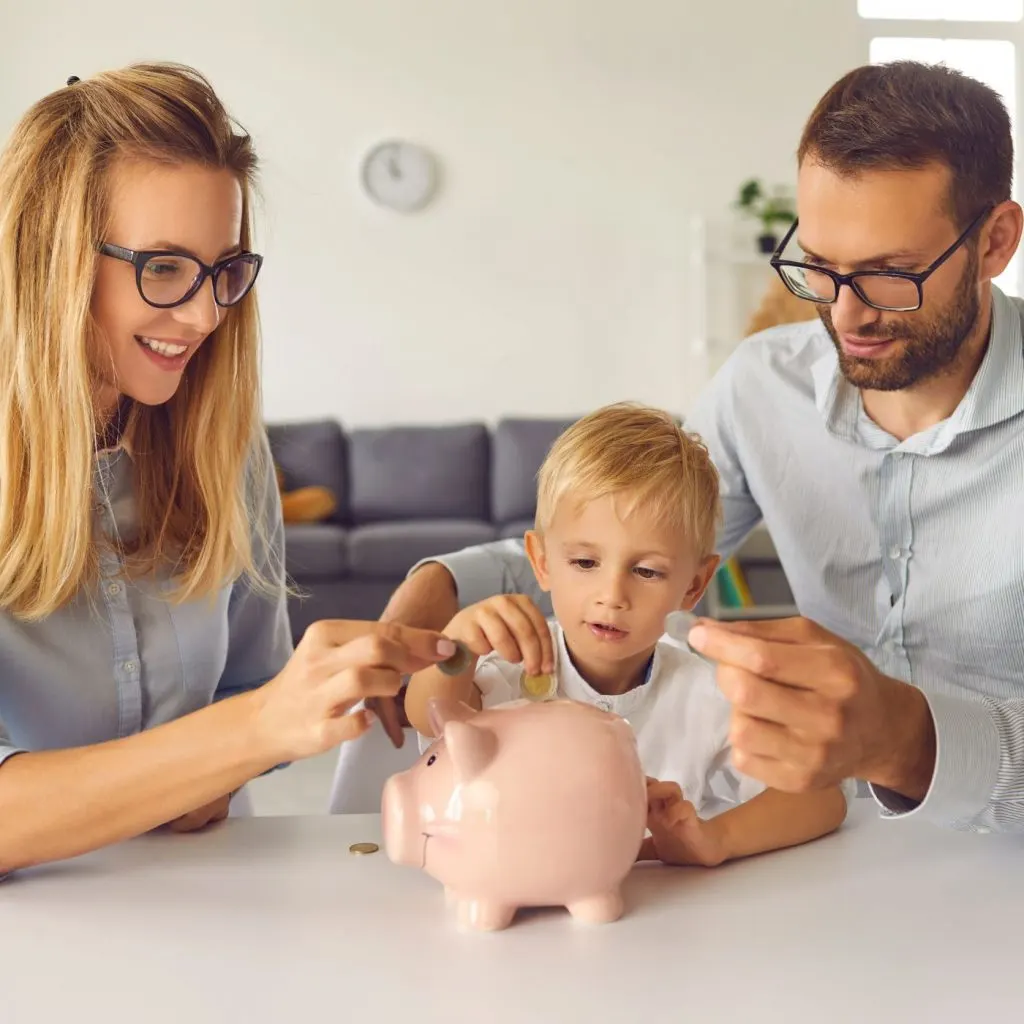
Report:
0,800,1024,1024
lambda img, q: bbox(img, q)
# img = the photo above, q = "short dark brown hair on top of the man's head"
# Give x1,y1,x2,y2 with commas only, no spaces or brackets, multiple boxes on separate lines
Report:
798,60,1014,228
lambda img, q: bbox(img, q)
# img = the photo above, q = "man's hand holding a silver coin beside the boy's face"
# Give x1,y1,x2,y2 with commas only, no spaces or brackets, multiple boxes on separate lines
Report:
689,618,935,800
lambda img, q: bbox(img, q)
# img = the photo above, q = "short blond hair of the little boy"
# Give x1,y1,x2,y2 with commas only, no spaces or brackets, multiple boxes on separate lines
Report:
537,402,719,558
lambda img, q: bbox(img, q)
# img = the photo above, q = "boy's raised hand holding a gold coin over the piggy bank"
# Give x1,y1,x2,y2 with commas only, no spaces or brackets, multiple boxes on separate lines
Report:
444,594,555,676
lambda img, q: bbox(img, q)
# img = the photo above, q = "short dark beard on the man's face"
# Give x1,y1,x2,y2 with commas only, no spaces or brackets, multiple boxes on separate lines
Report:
817,250,981,391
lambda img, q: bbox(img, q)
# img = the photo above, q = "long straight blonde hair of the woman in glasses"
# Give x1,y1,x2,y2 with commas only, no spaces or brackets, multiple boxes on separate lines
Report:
0,63,268,620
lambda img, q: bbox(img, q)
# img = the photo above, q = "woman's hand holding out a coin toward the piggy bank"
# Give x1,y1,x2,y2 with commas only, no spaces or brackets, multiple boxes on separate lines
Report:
254,620,456,761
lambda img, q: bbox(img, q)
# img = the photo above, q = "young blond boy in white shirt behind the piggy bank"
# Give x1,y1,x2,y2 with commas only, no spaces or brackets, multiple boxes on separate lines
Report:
406,403,847,866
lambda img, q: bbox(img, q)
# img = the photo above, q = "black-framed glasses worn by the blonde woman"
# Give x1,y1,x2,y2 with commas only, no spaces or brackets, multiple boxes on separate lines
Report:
98,242,263,309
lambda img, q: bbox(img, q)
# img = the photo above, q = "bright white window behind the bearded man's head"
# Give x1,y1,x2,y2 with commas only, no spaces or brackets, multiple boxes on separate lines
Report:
857,8,1024,295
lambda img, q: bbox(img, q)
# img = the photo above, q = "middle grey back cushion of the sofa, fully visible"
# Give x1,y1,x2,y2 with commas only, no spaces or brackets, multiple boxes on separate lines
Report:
348,423,490,524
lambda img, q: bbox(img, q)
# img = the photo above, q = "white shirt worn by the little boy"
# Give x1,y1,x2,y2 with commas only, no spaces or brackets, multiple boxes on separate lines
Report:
420,622,786,817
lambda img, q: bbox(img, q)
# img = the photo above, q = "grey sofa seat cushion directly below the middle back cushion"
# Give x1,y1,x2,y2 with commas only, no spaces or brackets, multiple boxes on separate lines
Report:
348,519,498,580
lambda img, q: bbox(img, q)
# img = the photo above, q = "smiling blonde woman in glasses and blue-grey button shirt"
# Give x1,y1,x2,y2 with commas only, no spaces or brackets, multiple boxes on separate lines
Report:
0,65,454,872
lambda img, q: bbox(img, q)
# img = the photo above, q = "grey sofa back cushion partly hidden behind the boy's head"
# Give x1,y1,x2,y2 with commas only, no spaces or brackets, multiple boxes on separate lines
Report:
490,419,575,522
